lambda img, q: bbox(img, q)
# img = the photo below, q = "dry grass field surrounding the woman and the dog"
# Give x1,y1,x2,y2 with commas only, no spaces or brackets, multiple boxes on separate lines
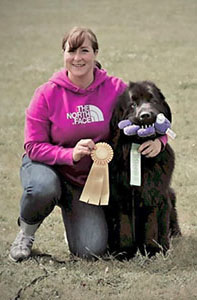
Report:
0,0,197,300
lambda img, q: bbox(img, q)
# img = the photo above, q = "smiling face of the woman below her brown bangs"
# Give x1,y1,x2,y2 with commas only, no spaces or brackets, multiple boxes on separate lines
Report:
64,37,98,79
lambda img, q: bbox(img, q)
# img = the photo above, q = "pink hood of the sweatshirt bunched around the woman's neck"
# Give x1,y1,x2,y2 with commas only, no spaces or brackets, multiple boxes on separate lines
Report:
49,67,107,94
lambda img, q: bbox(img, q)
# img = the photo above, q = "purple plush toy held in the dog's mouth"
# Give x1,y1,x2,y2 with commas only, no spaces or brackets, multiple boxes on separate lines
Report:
118,113,176,138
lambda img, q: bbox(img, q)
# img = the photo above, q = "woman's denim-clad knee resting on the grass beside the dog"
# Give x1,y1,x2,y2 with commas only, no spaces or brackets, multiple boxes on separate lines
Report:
61,191,108,258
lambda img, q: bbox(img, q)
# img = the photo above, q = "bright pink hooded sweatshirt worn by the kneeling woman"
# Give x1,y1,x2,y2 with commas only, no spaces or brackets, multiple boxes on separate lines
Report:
24,68,127,185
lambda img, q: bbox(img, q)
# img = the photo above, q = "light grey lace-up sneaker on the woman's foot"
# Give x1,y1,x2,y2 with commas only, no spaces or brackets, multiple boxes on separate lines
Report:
9,230,34,262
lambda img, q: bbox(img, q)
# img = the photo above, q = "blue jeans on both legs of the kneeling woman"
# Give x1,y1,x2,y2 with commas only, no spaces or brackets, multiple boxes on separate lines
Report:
20,155,108,257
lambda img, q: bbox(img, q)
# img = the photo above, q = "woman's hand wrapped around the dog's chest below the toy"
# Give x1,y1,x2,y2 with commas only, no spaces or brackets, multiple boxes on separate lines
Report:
138,139,162,158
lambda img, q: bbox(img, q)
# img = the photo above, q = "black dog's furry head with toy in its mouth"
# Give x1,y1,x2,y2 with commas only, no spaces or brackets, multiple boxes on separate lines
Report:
111,81,172,144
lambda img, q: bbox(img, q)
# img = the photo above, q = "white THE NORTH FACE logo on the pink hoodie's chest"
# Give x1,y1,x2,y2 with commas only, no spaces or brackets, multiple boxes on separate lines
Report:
67,105,104,125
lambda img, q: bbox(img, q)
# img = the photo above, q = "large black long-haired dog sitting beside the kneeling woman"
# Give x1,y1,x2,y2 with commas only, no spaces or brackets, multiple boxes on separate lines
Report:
106,81,181,256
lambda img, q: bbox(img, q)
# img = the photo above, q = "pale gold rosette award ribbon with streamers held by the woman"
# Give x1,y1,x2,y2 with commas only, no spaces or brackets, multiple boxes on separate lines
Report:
80,143,113,205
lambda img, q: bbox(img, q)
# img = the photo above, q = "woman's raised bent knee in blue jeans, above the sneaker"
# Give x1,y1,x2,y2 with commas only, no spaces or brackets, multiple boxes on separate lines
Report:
20,159,61,224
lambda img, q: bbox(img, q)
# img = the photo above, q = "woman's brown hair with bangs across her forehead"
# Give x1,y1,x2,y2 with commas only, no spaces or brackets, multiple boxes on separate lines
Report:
62,27,99,52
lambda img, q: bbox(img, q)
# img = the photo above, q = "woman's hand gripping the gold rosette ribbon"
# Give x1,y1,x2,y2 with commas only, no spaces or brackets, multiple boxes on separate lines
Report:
73,139,96,162
